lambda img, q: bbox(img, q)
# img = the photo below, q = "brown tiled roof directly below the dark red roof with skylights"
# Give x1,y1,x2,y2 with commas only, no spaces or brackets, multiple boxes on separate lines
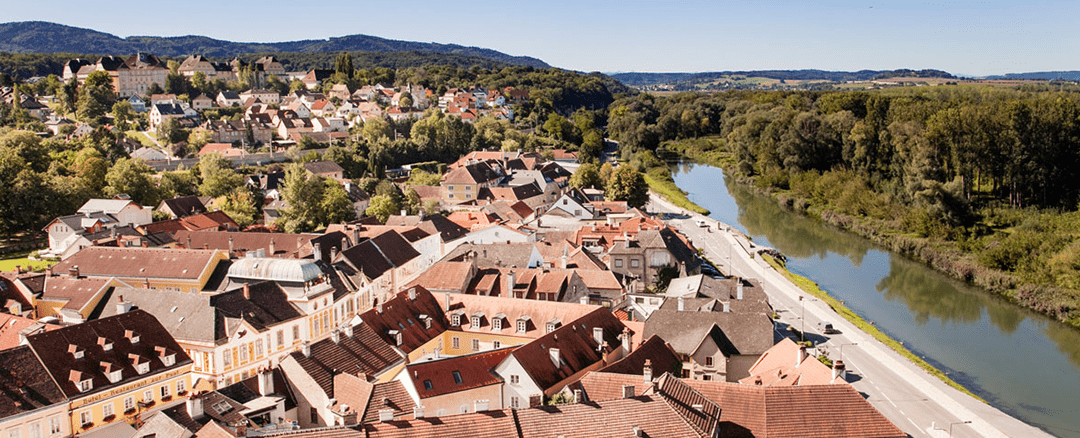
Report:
291,324,402,398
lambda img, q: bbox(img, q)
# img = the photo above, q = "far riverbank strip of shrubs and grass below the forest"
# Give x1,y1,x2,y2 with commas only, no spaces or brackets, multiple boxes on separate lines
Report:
664,139,1080,328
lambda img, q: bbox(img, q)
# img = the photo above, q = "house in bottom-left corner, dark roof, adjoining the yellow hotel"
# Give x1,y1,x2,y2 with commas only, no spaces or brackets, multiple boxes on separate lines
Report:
0,342,71,437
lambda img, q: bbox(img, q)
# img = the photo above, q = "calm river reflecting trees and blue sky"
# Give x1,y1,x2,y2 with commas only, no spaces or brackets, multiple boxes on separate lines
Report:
673,164,1080,437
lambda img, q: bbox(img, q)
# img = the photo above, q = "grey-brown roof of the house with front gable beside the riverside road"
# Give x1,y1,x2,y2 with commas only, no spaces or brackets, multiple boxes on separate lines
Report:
644,309,773,356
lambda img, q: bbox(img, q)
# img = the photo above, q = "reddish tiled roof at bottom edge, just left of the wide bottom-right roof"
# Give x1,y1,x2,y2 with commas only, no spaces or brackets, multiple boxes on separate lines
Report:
516,396,708,438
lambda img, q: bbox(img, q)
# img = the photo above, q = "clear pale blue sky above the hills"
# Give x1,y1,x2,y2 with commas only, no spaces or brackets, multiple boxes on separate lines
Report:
0,0,1080,77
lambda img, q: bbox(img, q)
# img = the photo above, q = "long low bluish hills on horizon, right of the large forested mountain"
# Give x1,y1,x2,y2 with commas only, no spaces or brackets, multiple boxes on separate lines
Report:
609,69,956,86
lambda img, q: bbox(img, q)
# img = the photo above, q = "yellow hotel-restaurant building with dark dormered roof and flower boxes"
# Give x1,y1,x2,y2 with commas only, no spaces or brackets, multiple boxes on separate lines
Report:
27,311,192,435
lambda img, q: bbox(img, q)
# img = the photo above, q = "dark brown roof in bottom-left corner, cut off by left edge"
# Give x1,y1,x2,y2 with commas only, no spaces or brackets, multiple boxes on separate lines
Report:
0,345,67,420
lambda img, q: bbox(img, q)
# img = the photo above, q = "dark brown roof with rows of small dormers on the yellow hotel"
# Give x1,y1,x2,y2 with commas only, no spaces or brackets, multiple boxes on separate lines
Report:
27,311,191,397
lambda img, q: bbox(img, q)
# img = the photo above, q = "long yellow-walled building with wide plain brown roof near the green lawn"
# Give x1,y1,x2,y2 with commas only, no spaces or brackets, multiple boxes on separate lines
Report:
53,246,229,293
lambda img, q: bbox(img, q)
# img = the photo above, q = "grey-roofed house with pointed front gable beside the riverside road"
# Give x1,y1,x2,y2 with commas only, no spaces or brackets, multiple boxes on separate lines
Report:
644,309,773,382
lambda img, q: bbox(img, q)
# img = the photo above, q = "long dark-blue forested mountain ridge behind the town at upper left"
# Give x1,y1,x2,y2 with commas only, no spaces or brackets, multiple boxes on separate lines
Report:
0,22,550,68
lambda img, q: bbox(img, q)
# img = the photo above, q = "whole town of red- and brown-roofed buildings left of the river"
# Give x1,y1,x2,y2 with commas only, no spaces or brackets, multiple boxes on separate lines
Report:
0,53,908,438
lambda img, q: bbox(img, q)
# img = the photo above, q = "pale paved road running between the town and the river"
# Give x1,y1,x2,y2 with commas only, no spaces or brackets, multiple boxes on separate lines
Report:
646,193,1051,438
